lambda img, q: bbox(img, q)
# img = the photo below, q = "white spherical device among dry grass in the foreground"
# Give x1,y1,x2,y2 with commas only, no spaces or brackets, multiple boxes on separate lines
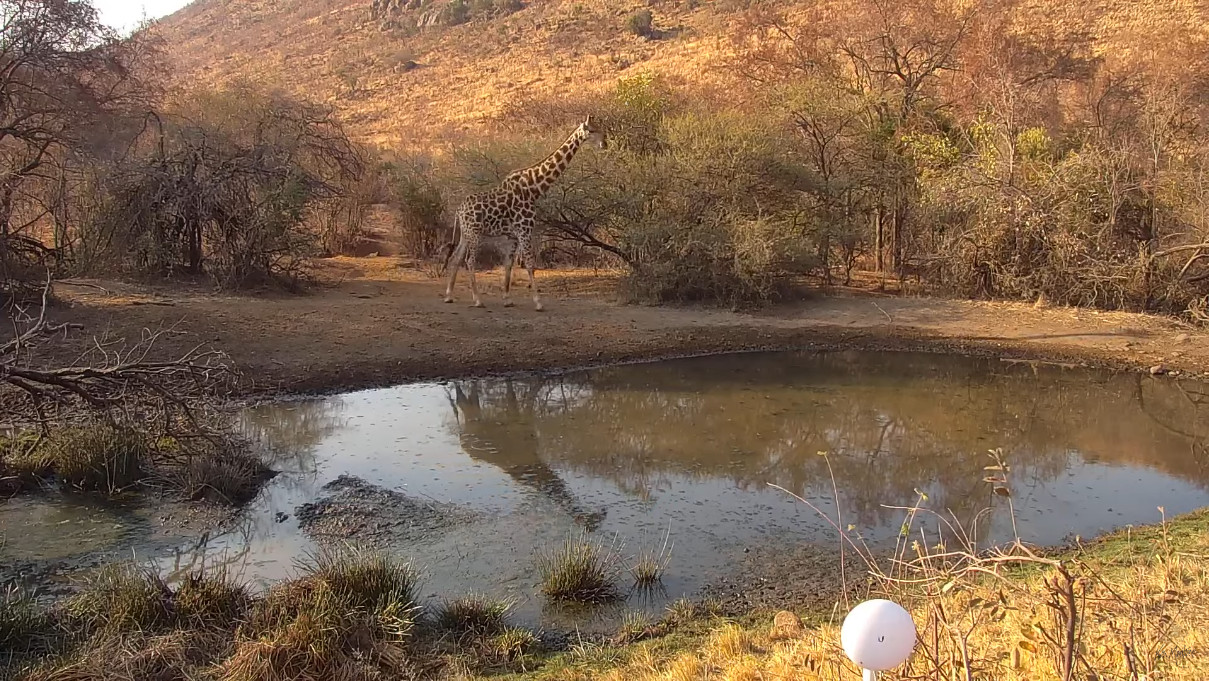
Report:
839,599,915,671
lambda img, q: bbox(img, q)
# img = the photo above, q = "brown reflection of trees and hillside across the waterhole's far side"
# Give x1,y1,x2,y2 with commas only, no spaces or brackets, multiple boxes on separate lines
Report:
451,352,1209,549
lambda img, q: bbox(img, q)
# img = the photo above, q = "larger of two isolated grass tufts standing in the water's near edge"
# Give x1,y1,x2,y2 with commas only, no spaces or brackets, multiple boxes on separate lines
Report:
537,533,620,604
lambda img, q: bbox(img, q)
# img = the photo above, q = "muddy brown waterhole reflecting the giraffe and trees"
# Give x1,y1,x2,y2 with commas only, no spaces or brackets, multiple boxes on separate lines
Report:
0,352,1209,630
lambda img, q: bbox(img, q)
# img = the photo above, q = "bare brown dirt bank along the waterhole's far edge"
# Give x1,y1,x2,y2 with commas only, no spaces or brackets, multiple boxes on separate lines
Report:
35,258,1209,394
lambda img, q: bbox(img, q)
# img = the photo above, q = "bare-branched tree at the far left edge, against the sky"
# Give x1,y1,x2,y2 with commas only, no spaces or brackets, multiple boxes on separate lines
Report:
0,0,149,300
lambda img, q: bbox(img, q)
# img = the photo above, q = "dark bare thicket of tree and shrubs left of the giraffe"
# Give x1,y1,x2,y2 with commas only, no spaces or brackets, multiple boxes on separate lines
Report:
0,0,372,305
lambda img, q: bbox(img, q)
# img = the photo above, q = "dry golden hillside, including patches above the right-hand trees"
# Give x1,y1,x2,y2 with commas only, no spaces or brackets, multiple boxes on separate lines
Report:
156,0,1209,145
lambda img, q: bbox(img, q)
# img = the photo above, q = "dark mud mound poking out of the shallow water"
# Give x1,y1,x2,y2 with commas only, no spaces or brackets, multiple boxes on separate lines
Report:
295,475,478,546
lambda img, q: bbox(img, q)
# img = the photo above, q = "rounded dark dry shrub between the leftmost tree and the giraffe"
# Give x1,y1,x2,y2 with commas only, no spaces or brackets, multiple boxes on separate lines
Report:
69,86,370,288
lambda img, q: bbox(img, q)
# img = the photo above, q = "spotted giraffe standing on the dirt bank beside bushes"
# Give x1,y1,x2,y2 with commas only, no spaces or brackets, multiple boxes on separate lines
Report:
441,116,607,312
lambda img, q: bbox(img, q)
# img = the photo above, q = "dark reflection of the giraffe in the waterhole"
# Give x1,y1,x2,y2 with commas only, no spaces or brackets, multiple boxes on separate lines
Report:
446,379,605,531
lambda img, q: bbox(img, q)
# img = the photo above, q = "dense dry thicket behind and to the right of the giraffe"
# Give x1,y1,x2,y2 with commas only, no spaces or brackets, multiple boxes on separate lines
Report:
403,0,1209,321
